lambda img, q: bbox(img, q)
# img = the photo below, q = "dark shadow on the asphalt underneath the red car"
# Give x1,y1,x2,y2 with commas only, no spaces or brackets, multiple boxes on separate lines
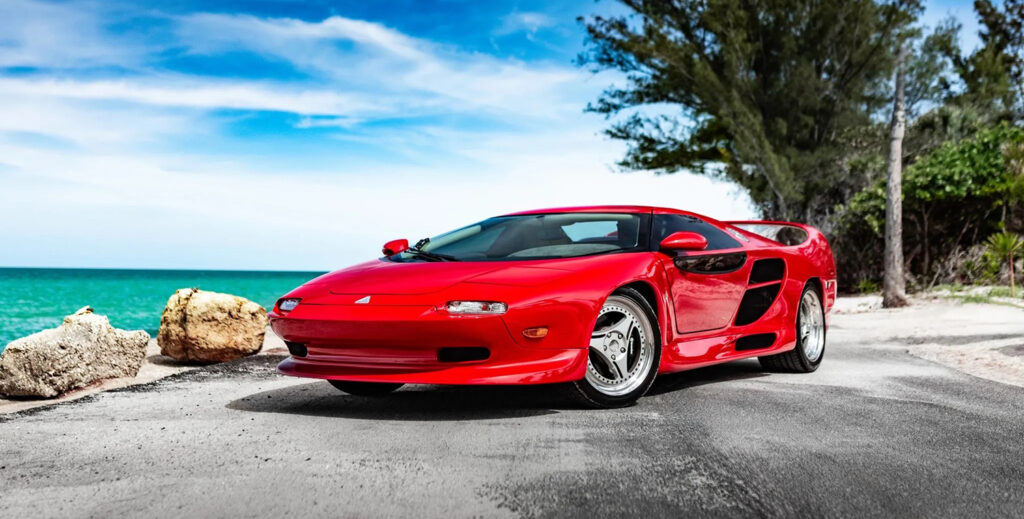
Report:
227,360,767,422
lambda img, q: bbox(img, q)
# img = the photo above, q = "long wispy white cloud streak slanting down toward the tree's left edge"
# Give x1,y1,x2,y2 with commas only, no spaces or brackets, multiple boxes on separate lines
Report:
178,14,595,117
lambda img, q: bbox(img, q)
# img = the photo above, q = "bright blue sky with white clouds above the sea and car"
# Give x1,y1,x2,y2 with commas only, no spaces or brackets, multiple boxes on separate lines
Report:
0,0,977,270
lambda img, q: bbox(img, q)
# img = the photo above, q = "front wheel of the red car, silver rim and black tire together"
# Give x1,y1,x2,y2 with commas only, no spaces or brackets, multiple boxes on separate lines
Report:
568,289,662,407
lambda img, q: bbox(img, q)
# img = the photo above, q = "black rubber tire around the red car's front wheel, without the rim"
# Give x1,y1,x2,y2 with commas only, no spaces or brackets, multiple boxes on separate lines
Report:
565,288,662,408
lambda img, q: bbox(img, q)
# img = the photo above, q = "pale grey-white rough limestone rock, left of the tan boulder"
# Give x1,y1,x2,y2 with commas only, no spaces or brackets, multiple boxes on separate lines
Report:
0,306,150,398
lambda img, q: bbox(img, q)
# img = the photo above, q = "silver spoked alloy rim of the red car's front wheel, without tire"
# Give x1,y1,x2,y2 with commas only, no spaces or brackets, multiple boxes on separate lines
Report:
586,296,654,396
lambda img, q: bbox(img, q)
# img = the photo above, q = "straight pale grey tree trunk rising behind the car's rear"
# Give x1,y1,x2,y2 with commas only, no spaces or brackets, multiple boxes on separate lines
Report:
882,45,907,308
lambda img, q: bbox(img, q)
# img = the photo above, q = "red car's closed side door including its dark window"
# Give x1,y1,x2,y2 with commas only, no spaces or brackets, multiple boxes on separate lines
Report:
652,214,750,334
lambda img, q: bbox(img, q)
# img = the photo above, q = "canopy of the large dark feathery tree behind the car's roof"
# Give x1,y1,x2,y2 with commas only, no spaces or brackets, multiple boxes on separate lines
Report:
580,0,921,223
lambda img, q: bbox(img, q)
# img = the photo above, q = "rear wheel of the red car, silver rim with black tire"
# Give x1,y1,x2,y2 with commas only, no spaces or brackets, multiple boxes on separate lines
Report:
758,284,825,373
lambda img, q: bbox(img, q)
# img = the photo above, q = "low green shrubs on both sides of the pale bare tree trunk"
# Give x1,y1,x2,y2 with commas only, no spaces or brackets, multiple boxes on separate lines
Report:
835,124,1024,286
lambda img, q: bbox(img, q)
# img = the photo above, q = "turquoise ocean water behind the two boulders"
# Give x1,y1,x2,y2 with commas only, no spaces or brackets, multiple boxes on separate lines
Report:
0,268,323,351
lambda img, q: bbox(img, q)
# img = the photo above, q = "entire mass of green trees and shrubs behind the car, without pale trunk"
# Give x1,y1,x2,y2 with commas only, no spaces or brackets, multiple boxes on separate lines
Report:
580,0,1024,288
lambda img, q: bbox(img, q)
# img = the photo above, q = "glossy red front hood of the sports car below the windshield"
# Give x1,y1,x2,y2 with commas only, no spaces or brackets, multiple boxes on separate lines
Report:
310,260,572,296
